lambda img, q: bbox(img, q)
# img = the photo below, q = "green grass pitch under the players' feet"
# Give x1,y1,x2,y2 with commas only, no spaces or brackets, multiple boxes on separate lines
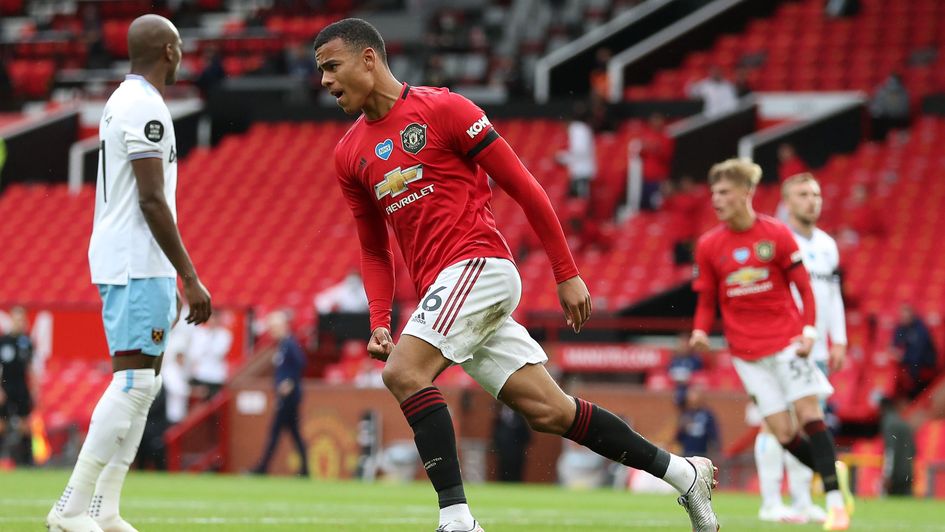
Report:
0,470,945,532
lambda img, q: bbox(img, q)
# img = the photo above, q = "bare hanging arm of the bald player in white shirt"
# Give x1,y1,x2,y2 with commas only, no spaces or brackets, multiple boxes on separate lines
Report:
131,157,213,324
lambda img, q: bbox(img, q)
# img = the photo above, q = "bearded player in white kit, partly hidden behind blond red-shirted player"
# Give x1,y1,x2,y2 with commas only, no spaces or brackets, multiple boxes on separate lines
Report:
755,173,851,523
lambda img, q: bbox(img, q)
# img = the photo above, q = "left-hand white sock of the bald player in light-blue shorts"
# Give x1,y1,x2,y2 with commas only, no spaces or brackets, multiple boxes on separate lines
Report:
55,369,154,517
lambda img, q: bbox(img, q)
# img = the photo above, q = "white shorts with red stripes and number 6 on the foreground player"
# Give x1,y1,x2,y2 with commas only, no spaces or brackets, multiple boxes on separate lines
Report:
401,258,548,397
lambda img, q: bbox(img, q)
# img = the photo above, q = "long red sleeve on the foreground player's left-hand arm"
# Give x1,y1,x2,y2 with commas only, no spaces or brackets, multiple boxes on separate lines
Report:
335,145,394,331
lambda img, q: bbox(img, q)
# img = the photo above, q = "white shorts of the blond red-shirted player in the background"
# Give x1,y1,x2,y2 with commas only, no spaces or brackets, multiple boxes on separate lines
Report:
732,344,833,417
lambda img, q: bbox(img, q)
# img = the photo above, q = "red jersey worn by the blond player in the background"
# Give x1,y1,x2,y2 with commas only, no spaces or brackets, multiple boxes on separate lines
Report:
693,215,806,360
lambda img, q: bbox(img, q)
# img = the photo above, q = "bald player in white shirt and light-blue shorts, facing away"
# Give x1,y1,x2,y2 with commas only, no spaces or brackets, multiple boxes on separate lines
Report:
46,15,211,532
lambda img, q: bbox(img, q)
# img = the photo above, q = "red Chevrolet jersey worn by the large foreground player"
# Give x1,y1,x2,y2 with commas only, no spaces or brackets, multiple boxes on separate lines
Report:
335,84,512,295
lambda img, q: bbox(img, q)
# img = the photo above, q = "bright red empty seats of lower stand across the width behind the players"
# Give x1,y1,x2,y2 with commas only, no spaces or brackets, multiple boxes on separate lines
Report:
0,118,945,432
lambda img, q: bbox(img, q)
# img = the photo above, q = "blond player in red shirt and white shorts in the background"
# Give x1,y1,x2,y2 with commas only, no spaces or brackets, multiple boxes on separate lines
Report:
690,159,850,530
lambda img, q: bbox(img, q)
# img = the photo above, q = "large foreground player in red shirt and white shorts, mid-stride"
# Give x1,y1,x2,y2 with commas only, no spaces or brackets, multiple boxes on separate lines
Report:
315,19,718,531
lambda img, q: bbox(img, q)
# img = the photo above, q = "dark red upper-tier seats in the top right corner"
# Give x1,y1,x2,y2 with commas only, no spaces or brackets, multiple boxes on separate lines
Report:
624,0,945,102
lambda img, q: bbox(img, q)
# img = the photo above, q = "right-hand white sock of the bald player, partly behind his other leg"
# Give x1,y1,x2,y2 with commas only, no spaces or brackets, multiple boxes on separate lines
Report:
89,375,162,522
